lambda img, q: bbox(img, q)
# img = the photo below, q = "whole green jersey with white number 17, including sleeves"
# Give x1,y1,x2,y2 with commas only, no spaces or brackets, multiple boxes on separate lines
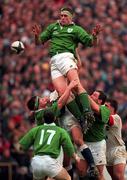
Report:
19,123,75,158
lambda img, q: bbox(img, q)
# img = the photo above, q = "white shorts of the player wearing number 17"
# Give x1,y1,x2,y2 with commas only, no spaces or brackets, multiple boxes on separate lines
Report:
31,155,63,179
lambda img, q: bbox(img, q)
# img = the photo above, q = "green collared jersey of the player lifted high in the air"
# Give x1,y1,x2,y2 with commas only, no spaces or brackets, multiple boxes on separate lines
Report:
39,22,93,56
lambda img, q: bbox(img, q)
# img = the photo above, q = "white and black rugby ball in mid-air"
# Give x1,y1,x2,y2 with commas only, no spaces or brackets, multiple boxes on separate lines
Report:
11,41,25,54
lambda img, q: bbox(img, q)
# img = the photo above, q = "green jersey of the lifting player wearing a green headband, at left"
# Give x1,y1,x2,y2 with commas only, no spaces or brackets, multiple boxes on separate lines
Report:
34,101,60,125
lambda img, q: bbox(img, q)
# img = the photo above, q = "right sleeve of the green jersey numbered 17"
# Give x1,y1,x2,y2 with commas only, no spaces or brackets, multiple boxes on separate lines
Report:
61,129,75,157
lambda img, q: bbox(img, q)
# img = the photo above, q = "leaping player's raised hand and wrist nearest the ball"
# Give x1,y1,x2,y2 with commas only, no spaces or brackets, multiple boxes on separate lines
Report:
32,24,41,45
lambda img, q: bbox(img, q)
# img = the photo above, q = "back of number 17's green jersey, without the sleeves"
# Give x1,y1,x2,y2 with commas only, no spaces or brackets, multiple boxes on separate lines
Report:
33,123,63,158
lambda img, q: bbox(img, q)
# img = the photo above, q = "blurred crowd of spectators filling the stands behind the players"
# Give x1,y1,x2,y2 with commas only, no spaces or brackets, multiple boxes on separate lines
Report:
0,0,127,178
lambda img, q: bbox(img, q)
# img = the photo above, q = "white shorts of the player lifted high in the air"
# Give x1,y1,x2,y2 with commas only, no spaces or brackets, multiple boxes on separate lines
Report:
51,52,77,79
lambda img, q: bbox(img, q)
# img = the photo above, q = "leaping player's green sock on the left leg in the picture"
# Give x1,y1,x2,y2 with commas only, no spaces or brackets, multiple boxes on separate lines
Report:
66,99,82,119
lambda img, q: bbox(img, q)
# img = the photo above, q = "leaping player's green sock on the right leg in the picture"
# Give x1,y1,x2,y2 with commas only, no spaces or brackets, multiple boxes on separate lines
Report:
78,92,91,112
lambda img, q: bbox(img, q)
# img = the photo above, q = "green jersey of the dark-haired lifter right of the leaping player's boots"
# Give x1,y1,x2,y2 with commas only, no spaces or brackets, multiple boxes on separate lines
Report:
84,105,110,142
